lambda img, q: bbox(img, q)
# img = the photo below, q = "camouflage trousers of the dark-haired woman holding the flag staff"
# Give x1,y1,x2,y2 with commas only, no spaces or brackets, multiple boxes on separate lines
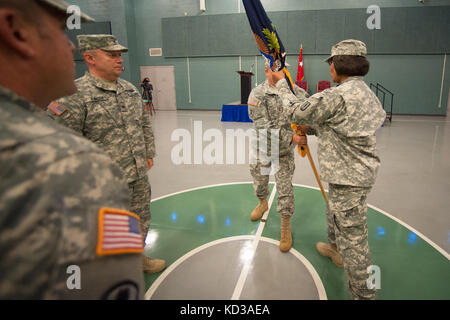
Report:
327,184,376,299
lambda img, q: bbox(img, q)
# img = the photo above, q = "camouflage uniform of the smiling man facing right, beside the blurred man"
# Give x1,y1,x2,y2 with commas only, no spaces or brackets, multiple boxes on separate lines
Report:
47,72,155,239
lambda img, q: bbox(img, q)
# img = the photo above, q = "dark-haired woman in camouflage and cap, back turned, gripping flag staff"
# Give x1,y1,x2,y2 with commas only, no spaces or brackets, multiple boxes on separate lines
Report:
266,39,386,299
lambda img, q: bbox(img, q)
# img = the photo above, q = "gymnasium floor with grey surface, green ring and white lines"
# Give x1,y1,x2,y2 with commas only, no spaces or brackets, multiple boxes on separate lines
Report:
145,111,450,300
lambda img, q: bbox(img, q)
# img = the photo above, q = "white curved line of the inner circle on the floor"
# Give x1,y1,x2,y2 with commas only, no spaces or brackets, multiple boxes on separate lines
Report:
144,235,328,300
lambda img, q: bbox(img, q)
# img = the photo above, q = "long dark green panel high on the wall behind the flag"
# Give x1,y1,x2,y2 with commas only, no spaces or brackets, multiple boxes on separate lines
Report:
162,6,450,58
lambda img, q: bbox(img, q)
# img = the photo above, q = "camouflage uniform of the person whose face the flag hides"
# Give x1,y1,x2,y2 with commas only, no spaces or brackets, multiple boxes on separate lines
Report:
248,80,306,216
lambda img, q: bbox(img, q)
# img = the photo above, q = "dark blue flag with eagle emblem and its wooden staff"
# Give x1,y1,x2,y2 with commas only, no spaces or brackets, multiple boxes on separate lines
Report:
242,0,327,201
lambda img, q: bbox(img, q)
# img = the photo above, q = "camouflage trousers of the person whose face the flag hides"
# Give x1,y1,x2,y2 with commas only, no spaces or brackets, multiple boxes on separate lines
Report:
250,151,295,216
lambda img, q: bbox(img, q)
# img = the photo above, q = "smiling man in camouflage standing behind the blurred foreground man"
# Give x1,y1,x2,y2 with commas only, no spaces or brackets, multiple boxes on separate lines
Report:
48,35,165,273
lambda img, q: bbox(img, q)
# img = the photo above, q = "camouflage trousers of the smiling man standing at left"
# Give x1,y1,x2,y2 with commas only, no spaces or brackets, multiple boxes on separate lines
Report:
128,176,152,241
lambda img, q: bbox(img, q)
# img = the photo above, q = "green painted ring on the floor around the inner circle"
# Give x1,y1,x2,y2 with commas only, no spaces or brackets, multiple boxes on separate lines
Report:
145,184,450,299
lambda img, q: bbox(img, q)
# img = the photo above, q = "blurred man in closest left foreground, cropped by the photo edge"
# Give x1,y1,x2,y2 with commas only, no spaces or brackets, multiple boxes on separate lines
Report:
0,0,144,299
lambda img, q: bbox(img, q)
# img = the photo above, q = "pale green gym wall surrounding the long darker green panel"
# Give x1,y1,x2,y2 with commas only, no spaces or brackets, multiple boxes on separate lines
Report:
69,0,450,115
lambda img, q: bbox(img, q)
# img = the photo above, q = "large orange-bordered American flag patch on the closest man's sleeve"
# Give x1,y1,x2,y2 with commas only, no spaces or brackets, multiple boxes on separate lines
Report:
97,208,144,256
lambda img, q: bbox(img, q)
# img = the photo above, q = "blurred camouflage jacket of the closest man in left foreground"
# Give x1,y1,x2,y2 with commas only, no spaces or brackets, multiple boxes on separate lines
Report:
0,87,144,299
